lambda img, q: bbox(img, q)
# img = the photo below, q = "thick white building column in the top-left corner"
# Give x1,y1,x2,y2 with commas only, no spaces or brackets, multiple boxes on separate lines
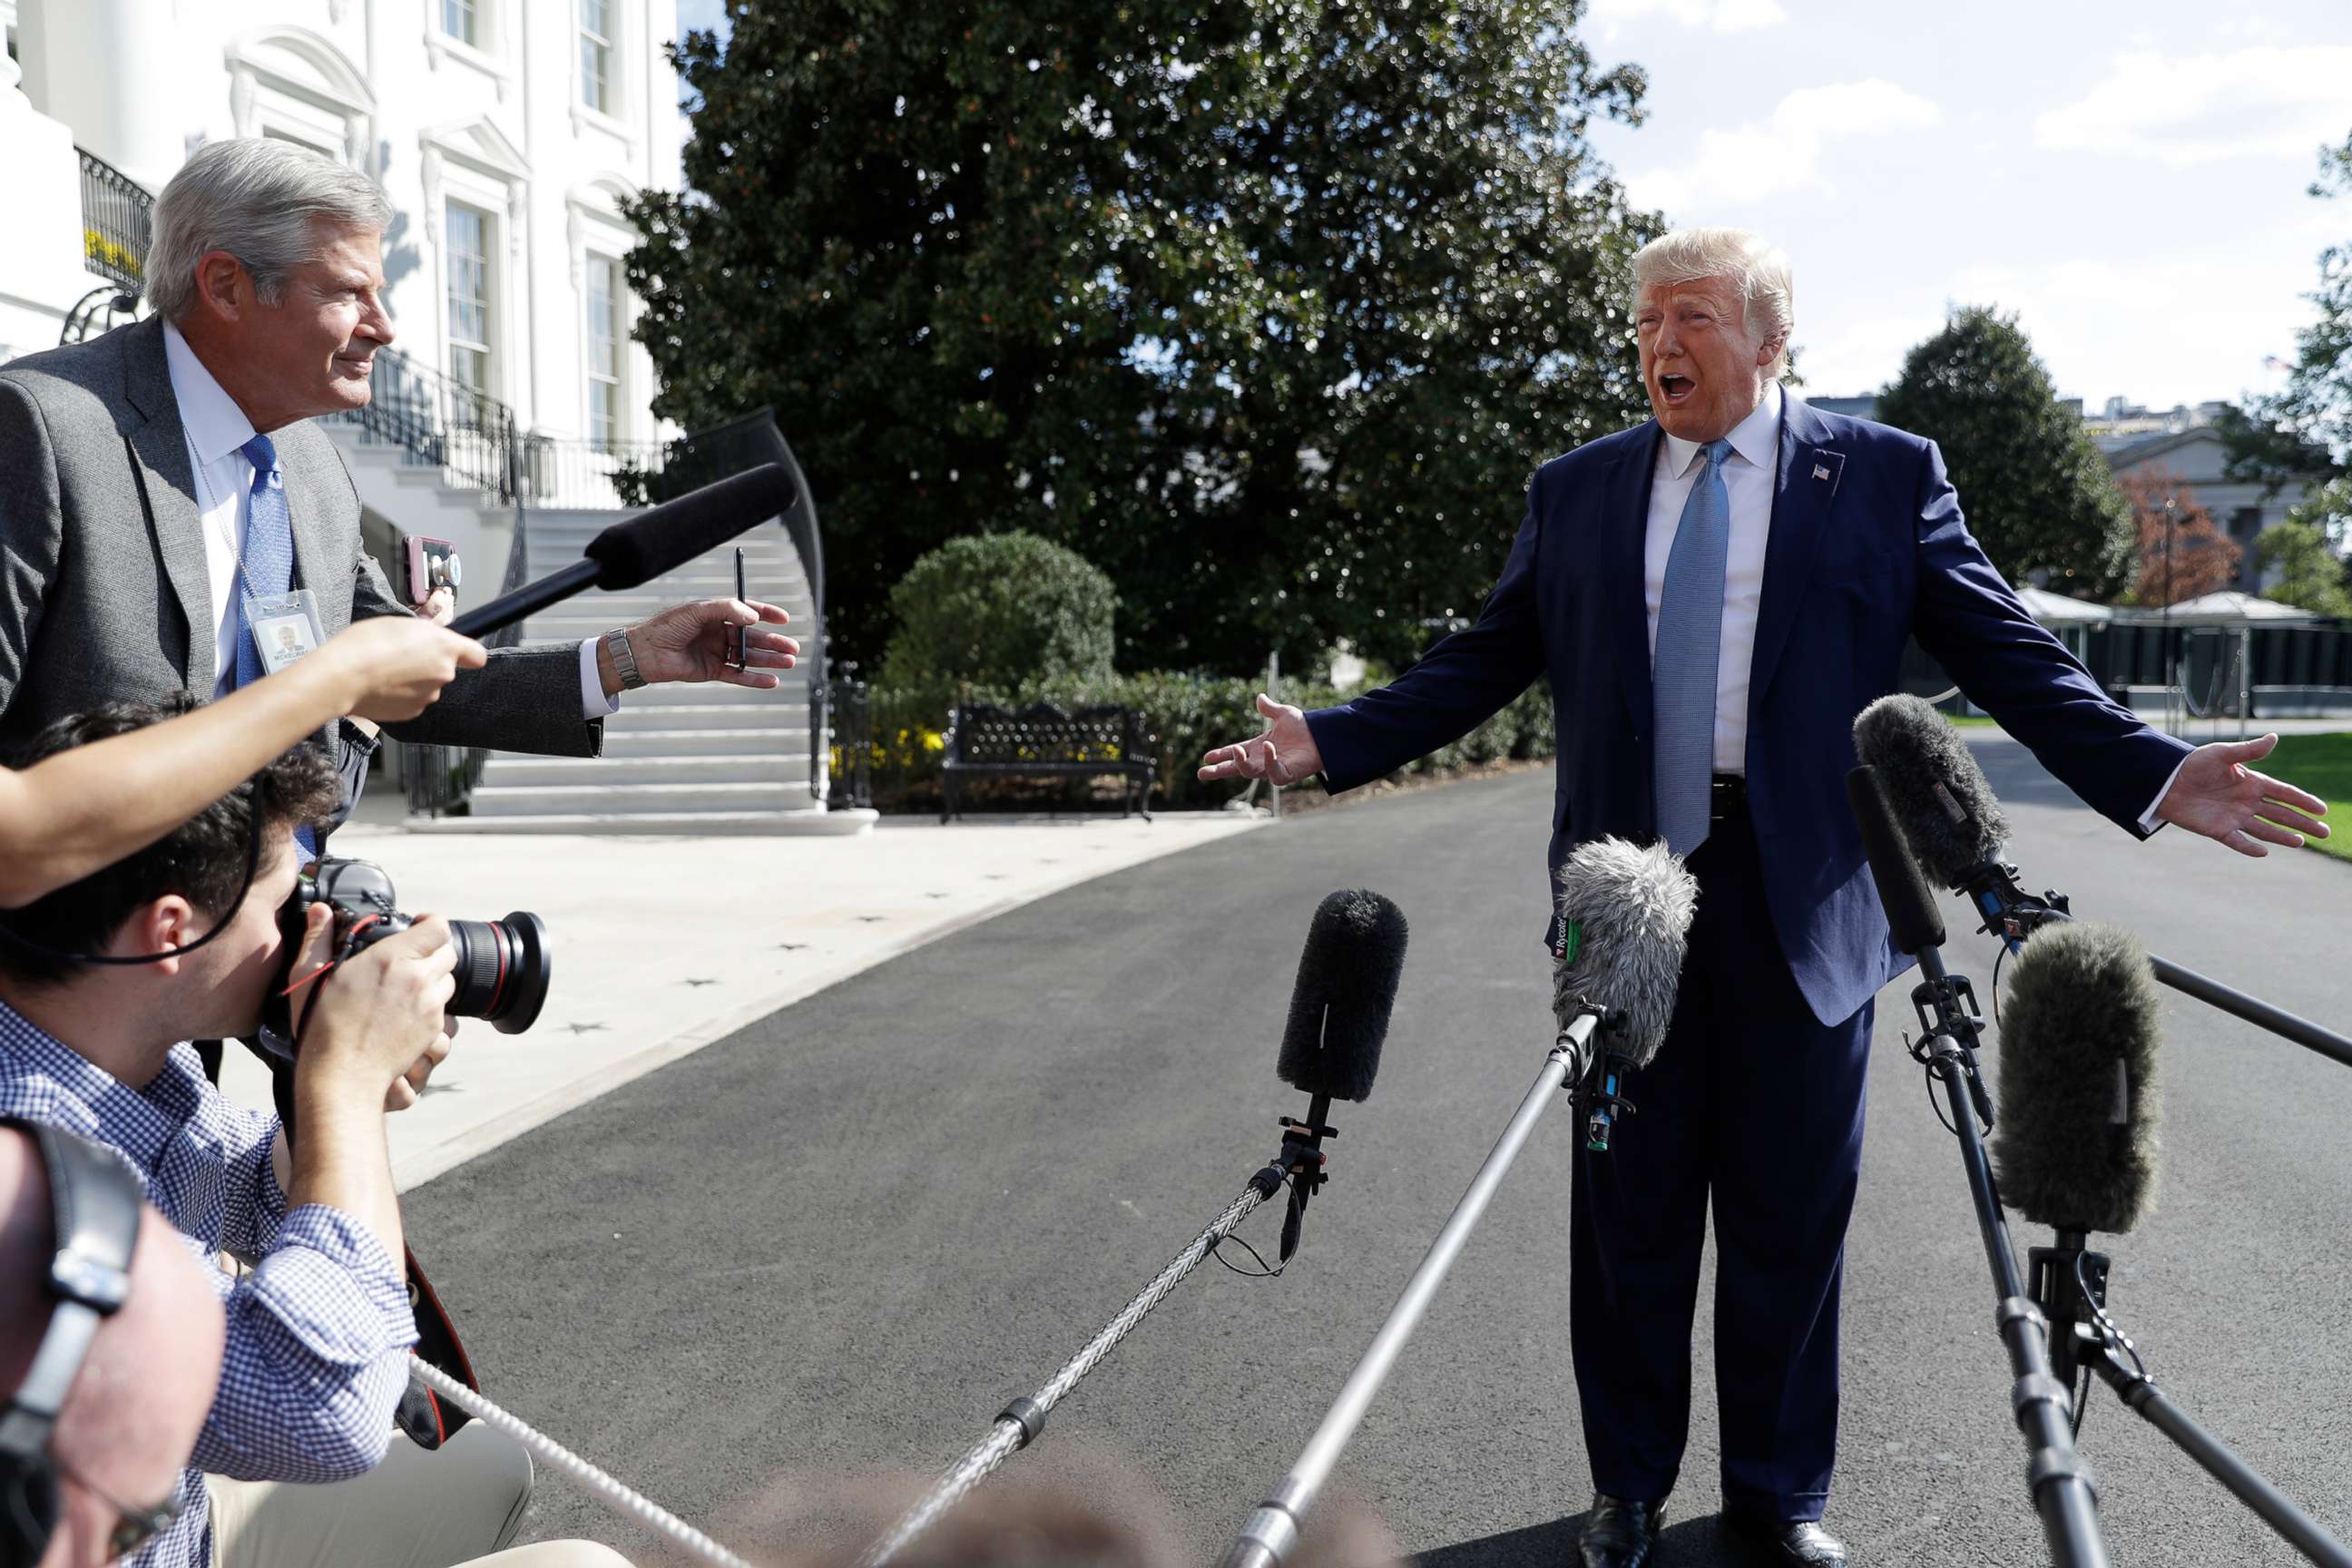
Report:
16,0,181,191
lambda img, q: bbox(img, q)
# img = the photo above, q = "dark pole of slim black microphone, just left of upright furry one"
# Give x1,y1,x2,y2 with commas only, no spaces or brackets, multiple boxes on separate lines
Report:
1906,943,2107,1568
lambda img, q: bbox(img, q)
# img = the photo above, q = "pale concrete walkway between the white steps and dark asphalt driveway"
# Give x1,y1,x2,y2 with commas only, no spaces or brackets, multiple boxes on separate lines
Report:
223,811,1265,1190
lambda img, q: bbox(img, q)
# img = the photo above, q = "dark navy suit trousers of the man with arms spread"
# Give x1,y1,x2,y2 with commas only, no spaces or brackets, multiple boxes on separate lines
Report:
1569,811,1870,1519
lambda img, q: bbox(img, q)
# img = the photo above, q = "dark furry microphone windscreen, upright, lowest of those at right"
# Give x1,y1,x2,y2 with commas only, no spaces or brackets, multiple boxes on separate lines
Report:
1992,922,2164,1232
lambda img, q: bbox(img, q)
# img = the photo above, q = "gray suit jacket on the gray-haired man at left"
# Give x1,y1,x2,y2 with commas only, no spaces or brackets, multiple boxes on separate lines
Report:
0,319,604,757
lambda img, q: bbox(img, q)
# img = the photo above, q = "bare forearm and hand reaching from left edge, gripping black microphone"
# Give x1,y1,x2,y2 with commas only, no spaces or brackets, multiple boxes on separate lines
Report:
0,616,485,910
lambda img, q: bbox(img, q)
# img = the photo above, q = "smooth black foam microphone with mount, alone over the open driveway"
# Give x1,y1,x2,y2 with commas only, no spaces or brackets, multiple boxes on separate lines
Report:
1275,888,1409,1262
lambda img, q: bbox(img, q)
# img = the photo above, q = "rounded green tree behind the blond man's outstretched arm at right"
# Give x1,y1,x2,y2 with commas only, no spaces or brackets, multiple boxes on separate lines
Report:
1879,306,2136,600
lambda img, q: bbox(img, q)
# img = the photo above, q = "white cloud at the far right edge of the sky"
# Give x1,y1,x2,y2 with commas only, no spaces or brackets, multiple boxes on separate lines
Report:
2034,44,2352,167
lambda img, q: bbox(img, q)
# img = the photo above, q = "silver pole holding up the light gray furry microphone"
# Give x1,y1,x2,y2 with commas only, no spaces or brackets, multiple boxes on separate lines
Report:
1220,1004,1618,1568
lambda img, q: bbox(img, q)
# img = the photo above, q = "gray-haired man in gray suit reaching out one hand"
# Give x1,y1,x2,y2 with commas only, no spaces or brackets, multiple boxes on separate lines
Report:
0,139,798,785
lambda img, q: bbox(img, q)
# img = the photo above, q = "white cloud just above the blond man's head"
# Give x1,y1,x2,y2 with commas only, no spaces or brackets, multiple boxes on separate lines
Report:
1625,77,1943,216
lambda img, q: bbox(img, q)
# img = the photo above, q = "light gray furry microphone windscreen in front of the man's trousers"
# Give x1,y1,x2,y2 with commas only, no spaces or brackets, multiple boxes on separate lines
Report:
1553,839,1698,1067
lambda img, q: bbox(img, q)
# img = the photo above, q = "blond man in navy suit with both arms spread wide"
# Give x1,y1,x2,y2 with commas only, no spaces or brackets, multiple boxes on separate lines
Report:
1200,228,2326,1568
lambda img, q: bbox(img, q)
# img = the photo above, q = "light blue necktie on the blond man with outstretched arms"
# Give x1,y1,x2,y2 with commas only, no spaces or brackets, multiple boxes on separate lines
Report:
1651,439,1731,856
